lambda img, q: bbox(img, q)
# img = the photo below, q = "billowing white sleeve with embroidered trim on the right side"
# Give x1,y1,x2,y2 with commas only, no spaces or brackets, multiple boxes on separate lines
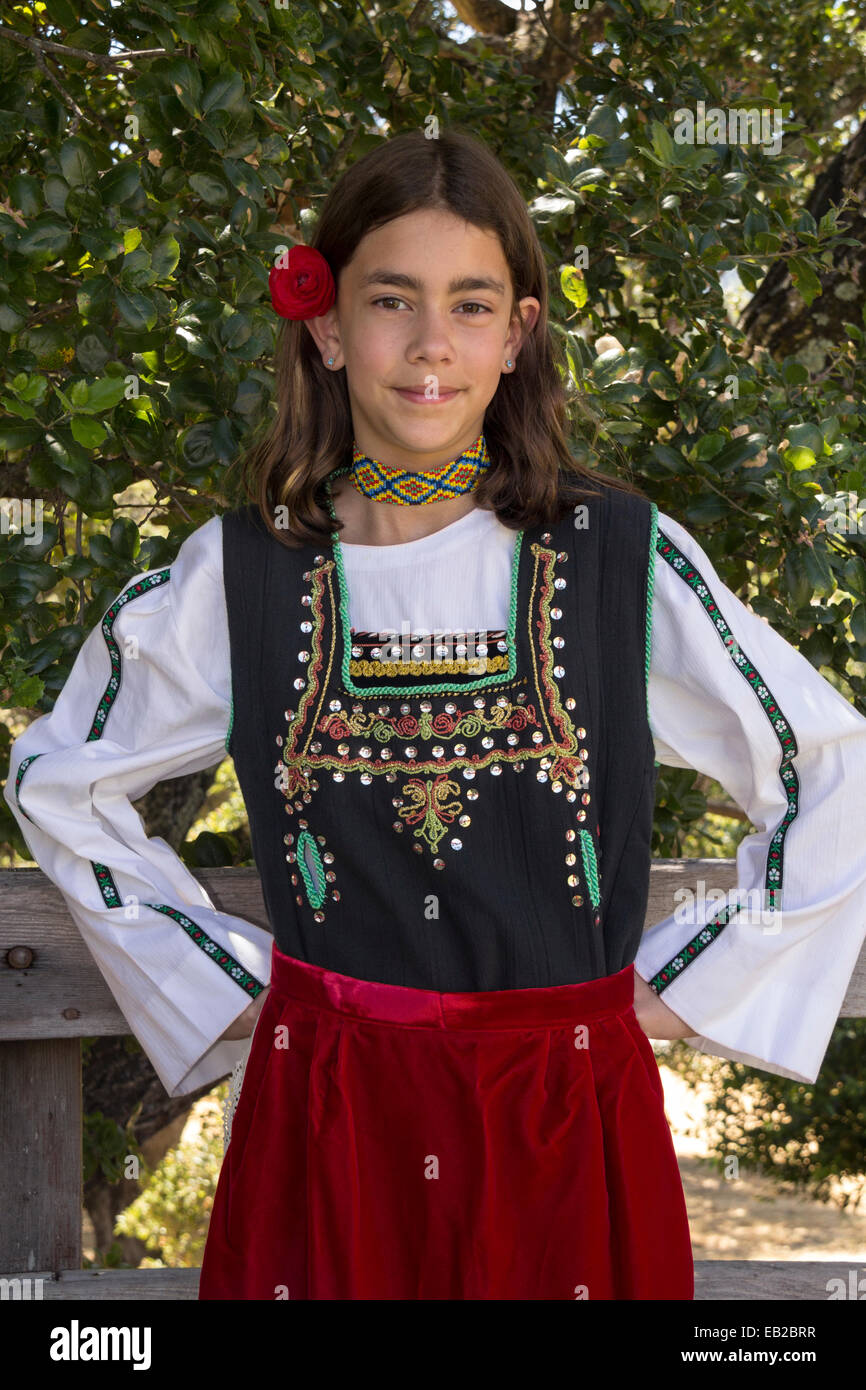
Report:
635,513,866,1081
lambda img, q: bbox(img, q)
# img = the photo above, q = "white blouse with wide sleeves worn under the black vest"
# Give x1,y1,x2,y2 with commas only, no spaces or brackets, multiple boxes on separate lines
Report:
4,509,866,1095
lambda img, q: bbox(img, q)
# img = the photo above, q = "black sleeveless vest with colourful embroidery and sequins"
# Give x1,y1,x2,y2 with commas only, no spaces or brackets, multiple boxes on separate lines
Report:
222,488,657,991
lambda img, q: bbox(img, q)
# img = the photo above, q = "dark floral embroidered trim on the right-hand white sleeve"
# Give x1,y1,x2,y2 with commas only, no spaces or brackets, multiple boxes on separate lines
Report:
649,530,799,994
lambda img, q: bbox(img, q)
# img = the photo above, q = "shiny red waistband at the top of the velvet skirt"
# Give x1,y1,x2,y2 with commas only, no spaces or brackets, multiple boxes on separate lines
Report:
271,944,634,1029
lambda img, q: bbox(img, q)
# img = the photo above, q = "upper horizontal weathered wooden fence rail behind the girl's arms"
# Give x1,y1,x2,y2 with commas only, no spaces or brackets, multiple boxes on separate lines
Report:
0,859,866,1040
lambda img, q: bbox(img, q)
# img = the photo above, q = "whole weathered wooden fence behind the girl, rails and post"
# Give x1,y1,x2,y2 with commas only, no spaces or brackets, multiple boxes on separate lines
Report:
0,859,866,1301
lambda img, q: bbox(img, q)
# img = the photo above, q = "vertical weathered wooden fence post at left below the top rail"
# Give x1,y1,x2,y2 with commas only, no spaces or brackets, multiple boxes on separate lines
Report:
0,1038,82,1269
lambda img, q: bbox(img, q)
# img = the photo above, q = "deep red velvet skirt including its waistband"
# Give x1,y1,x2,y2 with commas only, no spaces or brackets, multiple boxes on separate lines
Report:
199,947,694,1300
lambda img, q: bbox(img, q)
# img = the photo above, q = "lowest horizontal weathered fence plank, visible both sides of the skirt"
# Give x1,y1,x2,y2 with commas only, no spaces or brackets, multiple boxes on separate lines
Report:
0,1259,859,1302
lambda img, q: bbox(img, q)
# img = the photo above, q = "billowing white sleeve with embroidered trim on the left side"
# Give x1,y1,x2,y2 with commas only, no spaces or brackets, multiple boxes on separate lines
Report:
4,517,272,1097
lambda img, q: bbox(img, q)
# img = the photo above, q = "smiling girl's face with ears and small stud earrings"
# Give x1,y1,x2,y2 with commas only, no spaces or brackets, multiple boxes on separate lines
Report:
306,209,541,468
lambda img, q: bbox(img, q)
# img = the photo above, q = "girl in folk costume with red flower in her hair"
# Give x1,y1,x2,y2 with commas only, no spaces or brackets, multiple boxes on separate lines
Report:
7,132,866,1300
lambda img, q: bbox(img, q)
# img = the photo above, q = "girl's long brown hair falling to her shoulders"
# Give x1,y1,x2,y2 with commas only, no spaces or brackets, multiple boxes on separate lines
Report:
229,128,644,545
